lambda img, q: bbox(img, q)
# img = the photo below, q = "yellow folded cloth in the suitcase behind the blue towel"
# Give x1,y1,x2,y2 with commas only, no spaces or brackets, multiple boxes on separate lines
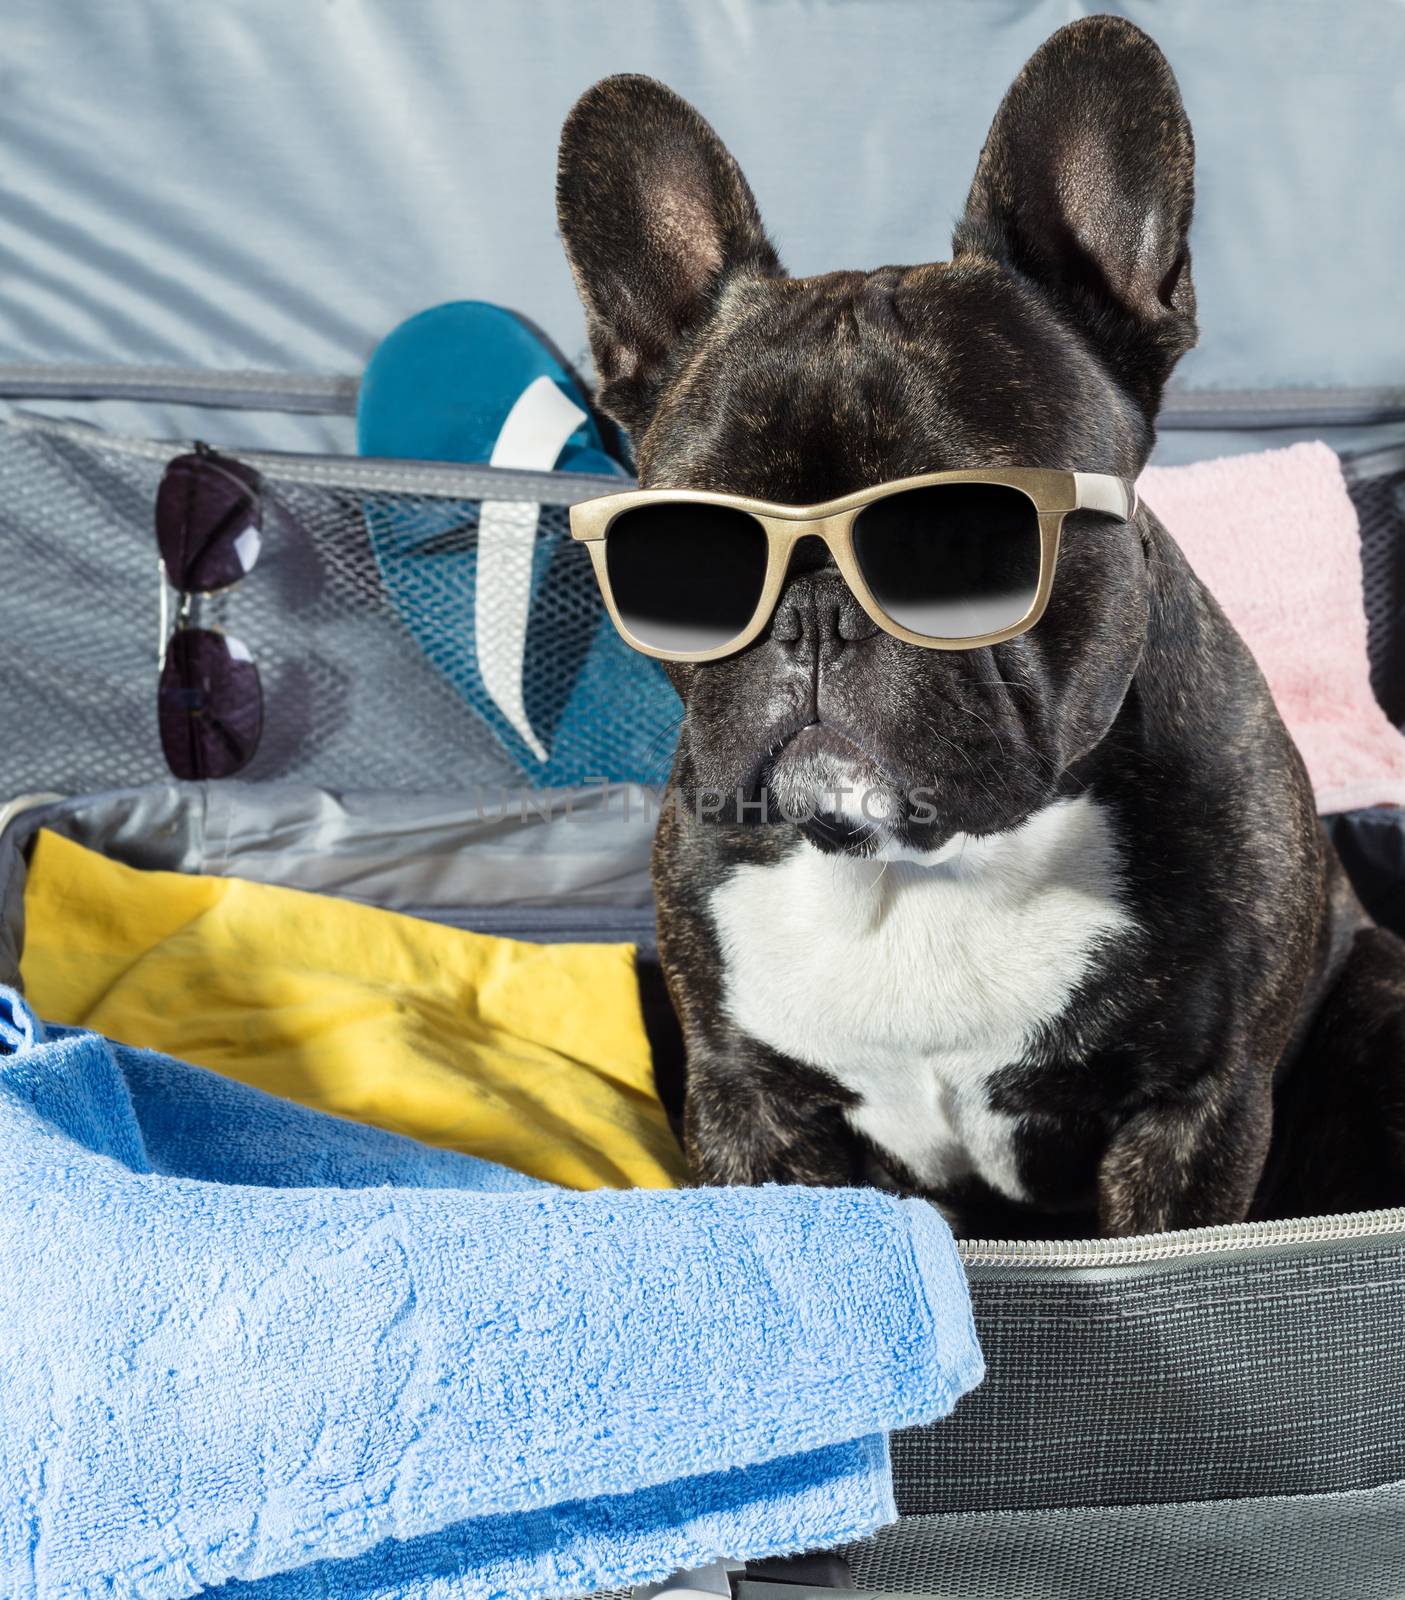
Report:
21,832,685,1189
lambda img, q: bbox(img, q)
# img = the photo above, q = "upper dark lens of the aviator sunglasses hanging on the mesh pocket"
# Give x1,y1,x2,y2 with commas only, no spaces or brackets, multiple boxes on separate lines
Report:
157,453,261,594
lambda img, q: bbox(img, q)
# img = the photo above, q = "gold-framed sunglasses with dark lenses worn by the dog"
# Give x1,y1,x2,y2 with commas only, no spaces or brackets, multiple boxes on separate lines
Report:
571,467,1136,661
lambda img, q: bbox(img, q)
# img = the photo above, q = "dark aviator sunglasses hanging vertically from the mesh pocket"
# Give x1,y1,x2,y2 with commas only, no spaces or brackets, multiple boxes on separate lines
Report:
155,443,264,779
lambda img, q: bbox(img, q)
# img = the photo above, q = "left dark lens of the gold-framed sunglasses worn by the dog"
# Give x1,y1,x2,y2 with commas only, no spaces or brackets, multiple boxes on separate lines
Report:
605,502,767,654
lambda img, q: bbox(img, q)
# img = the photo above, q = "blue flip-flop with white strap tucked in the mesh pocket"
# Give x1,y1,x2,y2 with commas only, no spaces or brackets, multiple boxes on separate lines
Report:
357,301,678,787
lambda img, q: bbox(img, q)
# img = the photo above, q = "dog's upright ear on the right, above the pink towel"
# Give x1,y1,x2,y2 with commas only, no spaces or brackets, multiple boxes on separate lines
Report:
954,16,1197,418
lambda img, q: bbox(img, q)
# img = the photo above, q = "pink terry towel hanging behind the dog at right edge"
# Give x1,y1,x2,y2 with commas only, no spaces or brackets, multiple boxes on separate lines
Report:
1138,443,1405,811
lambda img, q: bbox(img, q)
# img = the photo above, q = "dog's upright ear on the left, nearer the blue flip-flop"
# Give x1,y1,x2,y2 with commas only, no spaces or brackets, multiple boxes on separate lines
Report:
557,74,781,435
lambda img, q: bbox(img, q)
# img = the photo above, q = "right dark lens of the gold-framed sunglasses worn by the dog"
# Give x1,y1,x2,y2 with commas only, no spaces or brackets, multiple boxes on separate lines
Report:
853,483,1040,638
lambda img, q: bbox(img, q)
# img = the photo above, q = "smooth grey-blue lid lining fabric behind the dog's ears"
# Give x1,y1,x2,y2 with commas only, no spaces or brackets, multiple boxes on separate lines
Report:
0,0,1405,448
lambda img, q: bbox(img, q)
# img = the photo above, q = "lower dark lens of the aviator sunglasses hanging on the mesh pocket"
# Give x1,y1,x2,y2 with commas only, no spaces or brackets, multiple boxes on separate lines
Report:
157,627,264,781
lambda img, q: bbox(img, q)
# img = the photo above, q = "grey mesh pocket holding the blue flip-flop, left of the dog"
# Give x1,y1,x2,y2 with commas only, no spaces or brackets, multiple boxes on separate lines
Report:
0,427,680,803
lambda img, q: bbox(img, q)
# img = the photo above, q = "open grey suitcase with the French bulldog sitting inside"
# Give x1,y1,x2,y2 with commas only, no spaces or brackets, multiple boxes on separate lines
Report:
0,0,1405,1600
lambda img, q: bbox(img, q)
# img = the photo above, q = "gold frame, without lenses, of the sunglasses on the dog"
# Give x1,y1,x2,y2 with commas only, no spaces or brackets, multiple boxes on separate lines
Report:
571,467,1138,661
